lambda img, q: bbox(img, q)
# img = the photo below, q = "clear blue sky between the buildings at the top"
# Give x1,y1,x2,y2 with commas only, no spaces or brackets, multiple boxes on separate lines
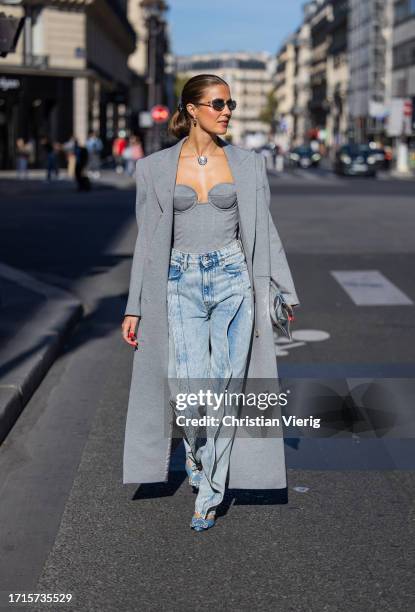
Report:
165,0,305,55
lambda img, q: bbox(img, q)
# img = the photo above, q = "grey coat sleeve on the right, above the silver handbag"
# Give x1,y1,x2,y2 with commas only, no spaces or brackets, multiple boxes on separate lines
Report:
258,153,300,306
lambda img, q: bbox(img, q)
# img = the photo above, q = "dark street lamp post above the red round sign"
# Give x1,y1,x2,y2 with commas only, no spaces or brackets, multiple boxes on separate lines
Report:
140,0,169,154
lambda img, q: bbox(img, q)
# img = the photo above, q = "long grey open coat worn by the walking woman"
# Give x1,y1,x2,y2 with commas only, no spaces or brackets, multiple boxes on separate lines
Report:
123,137,300,489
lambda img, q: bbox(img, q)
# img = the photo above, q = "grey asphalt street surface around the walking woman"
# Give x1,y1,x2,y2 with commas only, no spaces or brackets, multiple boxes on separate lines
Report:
0,169,415,612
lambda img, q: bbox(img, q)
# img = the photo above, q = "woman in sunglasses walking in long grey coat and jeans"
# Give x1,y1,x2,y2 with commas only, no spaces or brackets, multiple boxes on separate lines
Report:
122,74,299,531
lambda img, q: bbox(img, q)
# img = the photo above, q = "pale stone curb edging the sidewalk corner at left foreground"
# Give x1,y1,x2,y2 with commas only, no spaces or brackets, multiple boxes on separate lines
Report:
0,263,84,444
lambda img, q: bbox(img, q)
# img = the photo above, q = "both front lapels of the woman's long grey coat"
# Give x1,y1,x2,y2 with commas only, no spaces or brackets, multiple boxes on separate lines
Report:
148,136,257,259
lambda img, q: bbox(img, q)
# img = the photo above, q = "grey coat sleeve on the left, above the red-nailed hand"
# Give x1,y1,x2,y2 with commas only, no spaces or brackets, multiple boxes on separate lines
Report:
124,158,147,316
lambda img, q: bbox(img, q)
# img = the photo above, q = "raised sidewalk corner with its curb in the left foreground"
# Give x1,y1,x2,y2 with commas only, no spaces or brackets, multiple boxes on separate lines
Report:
0,263,83,443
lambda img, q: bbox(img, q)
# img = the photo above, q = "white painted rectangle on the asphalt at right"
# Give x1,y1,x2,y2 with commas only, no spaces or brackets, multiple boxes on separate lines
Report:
331,270,413,306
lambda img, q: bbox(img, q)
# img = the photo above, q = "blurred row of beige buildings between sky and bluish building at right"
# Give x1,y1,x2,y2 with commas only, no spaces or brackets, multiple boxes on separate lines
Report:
275,0,349,148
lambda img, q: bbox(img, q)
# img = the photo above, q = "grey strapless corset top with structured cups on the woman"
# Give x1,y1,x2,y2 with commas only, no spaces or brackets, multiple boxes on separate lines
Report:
173,183,239,253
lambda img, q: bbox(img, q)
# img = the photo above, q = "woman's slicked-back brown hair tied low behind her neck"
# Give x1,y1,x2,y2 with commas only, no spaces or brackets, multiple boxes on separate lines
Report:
168,74,228,139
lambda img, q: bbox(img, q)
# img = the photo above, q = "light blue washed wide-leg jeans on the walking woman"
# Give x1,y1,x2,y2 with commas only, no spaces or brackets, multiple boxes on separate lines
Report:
167,239,253,517
